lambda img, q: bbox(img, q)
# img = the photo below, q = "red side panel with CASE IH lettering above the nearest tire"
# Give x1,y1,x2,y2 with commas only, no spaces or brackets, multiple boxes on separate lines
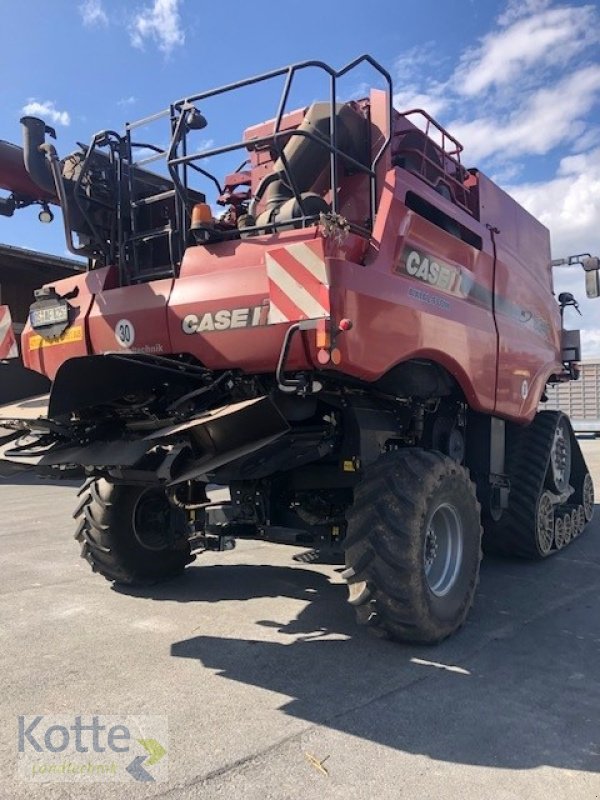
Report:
332,170,496,412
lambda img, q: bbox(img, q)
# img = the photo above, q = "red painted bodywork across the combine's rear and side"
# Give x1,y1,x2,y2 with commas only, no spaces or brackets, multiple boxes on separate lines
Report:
18,169,562,421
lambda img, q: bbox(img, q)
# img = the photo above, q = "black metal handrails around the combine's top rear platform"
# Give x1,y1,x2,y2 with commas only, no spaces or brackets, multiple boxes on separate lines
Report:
75,55,393,283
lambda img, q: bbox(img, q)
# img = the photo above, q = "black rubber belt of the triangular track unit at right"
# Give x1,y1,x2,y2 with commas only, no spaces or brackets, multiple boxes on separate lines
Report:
484,411,588,559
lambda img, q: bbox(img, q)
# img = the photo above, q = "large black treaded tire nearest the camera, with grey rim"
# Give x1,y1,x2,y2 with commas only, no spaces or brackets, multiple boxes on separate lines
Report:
344,448,482,643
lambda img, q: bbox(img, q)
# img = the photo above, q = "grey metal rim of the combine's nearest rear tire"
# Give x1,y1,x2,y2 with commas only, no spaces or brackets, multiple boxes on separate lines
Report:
423,503,464,597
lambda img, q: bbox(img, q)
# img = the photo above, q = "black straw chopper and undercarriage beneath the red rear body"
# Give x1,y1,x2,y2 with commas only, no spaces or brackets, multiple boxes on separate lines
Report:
4,354,467,545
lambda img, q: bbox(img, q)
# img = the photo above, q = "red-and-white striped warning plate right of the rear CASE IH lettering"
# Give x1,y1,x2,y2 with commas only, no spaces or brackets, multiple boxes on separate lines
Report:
265,240,330,325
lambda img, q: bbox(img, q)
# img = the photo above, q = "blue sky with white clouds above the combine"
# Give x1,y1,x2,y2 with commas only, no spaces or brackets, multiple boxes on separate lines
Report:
0,0,600,350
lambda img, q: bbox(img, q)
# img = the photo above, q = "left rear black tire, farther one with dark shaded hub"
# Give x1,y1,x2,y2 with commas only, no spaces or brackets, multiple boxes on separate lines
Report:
73,479,195,586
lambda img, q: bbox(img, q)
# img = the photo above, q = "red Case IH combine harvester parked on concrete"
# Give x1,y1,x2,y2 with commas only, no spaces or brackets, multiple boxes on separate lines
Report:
0,56,599,642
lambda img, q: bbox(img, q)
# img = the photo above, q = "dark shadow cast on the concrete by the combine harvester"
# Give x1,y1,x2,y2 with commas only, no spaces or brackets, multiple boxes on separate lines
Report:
117,512,600,771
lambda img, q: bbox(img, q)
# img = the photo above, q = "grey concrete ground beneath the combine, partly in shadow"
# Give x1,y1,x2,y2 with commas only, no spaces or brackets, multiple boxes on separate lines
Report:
0,441,600,800
